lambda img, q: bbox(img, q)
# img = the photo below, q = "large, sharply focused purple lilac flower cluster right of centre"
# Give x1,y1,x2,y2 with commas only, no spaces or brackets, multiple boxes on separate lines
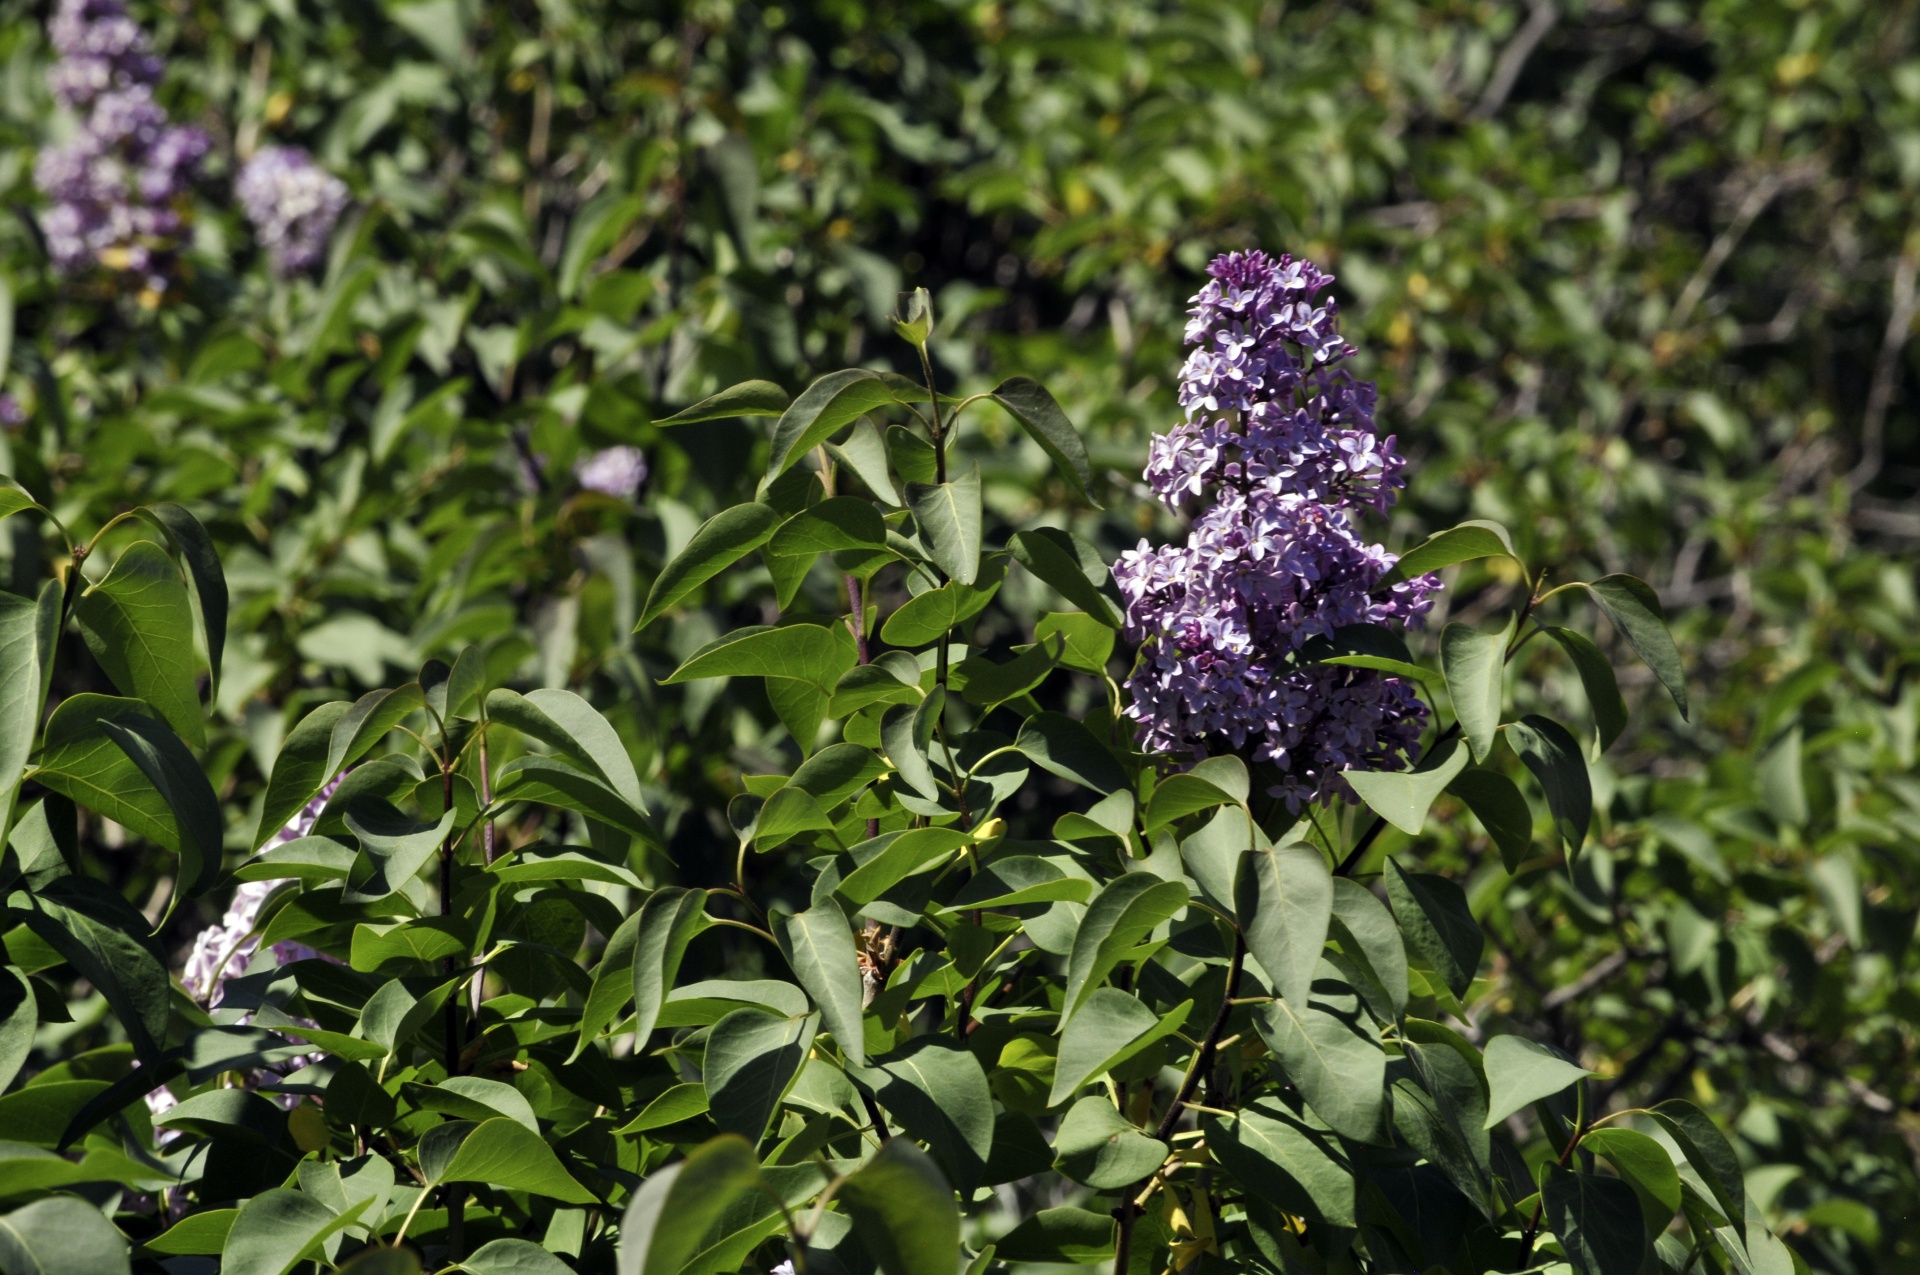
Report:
1114,252,1440,814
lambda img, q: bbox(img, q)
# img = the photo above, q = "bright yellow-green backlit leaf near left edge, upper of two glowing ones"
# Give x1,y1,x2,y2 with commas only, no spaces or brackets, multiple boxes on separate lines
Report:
73,540,207,749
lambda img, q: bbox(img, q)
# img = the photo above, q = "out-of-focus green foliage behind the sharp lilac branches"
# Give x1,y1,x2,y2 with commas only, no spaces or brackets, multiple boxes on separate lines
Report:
0,0,1920,1273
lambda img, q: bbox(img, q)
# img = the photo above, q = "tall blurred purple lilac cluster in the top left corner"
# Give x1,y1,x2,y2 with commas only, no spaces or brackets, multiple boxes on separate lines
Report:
33,0,209,294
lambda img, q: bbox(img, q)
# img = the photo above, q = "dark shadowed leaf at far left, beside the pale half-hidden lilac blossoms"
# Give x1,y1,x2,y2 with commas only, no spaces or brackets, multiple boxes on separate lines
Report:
8,875,173,1068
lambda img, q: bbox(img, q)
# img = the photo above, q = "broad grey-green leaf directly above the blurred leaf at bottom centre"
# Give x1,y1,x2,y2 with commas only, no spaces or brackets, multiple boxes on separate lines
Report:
852,1037,993,1194
